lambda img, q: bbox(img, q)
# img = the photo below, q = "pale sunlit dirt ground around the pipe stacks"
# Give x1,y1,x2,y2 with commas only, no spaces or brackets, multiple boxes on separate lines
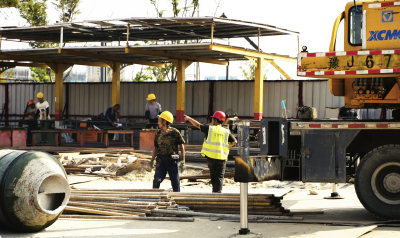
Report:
0,168,400,238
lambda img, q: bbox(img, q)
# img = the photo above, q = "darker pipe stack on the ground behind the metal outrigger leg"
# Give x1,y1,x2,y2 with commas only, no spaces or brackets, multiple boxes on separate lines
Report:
168,193,290,215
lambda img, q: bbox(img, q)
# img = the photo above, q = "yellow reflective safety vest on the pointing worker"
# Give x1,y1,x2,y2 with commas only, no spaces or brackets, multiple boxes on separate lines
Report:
201,125,229,160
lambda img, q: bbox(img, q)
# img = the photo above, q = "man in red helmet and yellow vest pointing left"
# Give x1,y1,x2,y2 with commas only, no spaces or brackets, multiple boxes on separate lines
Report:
184,111,237,193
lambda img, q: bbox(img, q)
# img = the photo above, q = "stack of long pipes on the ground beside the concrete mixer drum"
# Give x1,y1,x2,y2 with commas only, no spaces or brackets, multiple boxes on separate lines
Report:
61,189,193,221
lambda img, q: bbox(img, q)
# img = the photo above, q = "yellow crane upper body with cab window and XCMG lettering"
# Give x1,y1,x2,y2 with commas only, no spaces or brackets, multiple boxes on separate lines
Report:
298,1,400,109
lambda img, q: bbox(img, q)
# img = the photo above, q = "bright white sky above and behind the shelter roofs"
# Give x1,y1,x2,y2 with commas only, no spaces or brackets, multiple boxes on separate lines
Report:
0,0,349,79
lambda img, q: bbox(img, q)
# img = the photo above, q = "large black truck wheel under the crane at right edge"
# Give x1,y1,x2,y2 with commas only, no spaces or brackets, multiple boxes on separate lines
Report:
355,145,400,219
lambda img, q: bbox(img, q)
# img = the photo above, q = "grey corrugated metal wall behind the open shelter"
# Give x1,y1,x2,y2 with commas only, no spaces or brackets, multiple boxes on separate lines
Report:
0,80,390,119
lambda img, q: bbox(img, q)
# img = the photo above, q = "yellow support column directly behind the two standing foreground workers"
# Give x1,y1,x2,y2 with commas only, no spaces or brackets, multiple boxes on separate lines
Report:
174,60,192,122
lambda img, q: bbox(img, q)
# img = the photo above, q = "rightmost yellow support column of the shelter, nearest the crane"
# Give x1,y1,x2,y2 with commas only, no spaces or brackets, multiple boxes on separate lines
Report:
254,58,264,121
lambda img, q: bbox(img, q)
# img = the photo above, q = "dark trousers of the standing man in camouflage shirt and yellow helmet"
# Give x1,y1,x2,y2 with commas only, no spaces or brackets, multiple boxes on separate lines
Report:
153,155,181,192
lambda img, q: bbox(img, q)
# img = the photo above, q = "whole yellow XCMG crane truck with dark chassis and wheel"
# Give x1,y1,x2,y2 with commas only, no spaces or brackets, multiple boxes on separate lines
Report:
235,0,400,219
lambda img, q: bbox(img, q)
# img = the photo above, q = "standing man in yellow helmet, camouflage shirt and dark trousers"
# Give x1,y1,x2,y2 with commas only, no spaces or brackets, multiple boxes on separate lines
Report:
150,111,185,192
